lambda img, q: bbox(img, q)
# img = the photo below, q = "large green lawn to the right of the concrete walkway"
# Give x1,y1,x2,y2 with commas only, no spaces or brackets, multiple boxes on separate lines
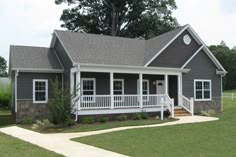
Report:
75,99,236,157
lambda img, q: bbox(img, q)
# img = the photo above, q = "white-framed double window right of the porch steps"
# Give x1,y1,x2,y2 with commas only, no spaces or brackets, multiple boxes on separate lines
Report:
194,80,211,101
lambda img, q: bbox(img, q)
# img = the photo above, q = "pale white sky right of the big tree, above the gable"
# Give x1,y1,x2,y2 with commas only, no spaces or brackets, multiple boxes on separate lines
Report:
174,0,236,47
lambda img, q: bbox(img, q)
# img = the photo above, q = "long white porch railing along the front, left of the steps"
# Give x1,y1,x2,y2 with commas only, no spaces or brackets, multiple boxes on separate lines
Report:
79,94,174,116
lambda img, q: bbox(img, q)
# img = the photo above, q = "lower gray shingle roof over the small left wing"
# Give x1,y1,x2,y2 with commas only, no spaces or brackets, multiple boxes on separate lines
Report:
10,46,63,70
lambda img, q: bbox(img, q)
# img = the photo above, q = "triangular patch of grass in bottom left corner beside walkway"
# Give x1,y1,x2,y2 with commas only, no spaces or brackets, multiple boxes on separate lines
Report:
0,133,61,157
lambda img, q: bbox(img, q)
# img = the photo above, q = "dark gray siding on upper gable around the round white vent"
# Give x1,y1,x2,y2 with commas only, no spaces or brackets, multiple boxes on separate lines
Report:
149,31,200,68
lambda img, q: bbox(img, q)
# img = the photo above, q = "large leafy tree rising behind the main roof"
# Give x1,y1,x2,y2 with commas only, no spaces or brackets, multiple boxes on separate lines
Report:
55,0,178,39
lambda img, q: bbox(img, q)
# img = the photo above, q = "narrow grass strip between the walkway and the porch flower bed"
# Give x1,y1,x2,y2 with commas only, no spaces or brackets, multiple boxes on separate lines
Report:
19,119,174,133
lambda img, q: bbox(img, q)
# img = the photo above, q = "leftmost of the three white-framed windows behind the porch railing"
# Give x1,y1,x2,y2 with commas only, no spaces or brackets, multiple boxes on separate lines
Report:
81,78,95,102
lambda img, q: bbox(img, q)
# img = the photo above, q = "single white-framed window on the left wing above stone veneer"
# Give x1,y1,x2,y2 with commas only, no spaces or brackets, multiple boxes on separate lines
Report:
33,79,48,103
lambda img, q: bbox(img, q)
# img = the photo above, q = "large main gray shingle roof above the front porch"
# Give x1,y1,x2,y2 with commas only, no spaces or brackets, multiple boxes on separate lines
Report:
55,26,184,66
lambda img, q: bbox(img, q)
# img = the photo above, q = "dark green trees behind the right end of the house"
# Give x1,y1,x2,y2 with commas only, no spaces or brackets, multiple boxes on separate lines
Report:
209,42,236,90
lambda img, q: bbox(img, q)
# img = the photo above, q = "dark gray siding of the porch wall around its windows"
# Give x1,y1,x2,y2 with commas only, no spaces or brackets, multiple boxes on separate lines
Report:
81,72,164,95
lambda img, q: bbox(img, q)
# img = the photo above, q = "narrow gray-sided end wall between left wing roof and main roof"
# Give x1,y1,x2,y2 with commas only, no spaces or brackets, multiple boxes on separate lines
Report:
54,39,73,86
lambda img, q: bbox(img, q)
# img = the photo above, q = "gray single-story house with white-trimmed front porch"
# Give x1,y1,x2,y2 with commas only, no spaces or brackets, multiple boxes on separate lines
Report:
9,25,226,120
